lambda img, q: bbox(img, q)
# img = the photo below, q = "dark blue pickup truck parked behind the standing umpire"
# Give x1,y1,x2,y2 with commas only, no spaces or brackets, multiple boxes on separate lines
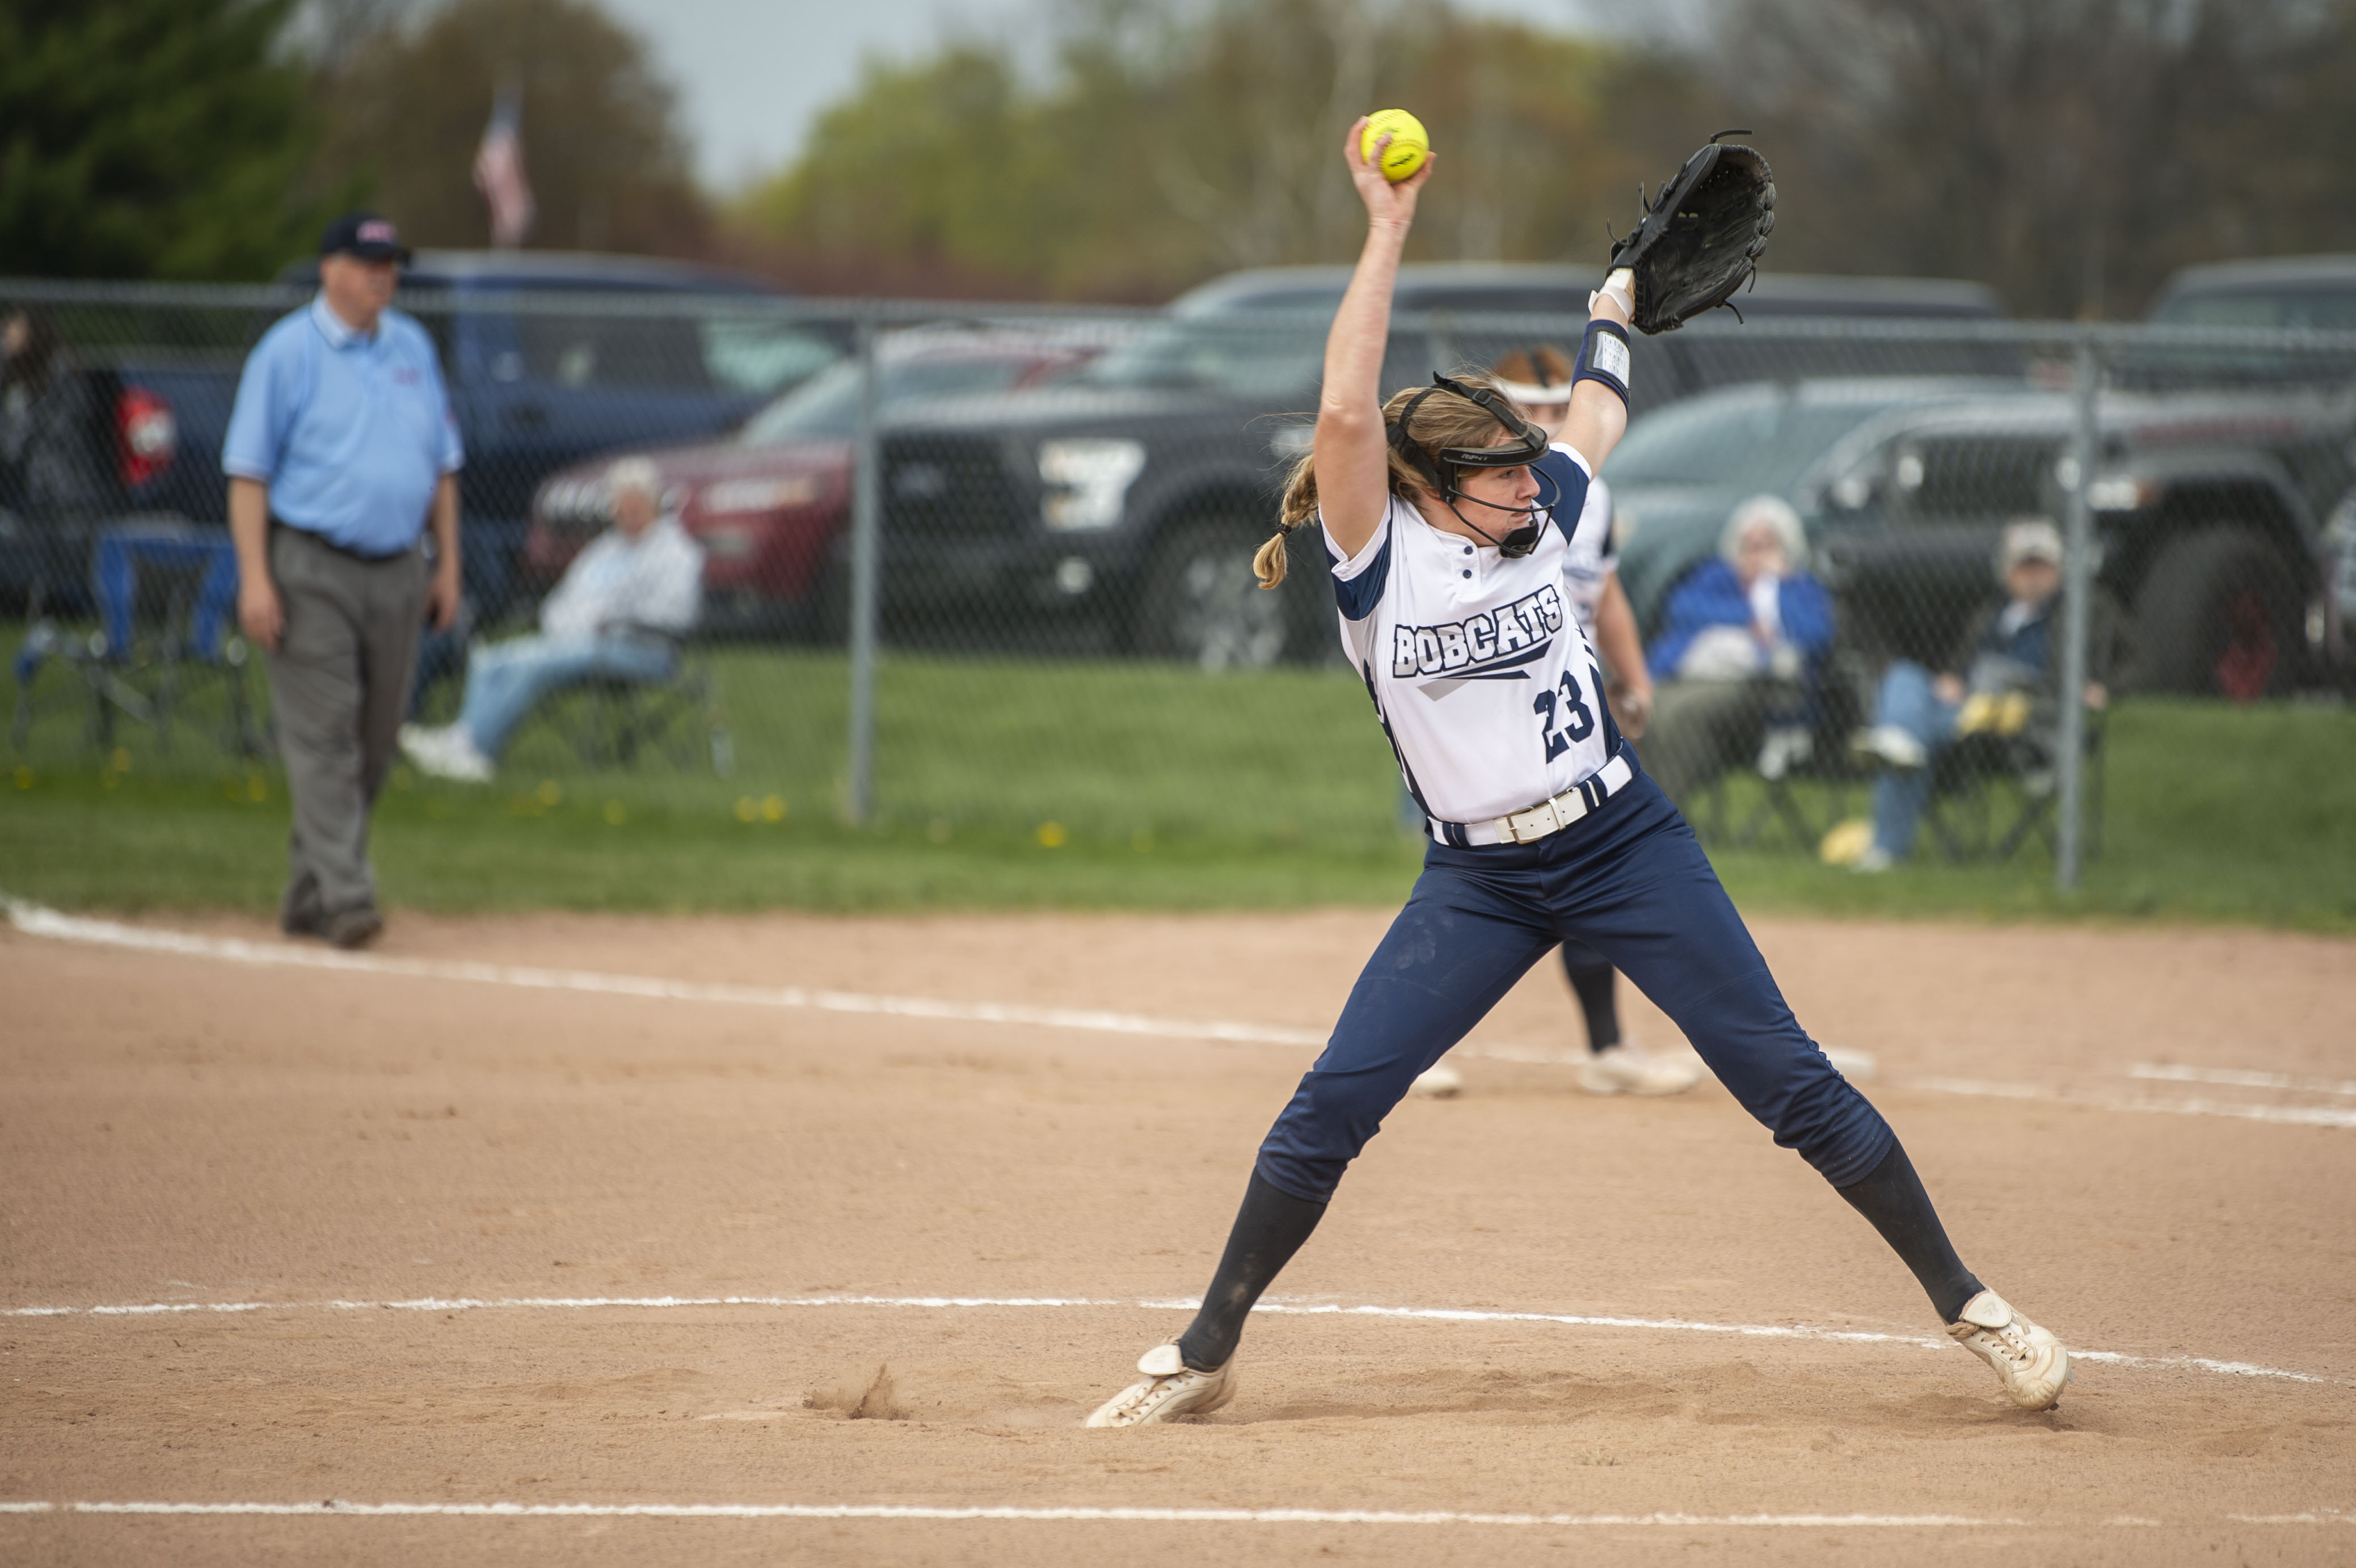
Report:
2,250,848,617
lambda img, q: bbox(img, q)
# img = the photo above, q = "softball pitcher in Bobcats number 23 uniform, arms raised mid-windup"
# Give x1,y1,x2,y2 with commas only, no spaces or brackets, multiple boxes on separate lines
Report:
1089,120,2068,1427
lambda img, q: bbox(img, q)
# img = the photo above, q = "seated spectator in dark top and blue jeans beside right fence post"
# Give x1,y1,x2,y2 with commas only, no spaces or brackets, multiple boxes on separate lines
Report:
1854,518,2125,871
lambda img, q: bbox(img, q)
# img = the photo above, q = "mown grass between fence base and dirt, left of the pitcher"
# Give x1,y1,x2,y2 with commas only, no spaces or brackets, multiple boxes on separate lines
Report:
0,774,1416,911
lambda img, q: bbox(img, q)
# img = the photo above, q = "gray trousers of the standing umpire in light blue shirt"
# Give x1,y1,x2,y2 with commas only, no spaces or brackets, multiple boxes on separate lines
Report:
268,528,427,923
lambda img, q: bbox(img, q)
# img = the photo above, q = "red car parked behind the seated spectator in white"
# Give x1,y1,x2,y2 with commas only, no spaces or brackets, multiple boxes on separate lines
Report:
523,327,1105,626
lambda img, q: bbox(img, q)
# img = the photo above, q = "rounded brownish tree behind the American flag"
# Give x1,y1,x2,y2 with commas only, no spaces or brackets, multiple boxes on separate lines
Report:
318,0,709,254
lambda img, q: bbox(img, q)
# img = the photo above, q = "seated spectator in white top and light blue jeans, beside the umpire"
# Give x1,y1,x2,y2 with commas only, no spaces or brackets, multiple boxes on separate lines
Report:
401,457,705,784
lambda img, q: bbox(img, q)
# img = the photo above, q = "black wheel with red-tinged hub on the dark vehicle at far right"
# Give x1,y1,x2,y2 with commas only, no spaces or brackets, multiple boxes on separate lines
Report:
2135,528,2302,702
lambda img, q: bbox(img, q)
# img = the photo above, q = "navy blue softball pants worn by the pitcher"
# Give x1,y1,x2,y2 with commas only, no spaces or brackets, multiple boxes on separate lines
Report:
1258,772,1896,1203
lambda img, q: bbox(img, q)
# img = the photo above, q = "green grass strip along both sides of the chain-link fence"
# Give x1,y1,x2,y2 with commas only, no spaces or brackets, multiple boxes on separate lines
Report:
0,626,2356,932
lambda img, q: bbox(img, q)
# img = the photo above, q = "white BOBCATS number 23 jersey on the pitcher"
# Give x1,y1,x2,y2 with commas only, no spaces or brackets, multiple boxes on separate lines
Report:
1326,445,1619,845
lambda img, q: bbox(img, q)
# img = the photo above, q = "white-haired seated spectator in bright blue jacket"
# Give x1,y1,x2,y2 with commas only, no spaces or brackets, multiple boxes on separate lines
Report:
1637,495,1833,803
